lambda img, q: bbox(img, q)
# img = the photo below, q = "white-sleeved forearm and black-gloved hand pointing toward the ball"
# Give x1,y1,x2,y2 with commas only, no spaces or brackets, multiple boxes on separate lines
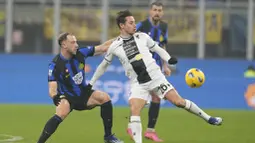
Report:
150,43,178,64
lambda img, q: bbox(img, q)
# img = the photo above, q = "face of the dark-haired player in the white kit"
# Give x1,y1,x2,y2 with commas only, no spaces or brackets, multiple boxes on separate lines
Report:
121,16,136,35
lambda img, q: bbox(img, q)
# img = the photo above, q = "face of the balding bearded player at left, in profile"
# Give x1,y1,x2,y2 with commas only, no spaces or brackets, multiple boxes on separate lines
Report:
65,35,78,55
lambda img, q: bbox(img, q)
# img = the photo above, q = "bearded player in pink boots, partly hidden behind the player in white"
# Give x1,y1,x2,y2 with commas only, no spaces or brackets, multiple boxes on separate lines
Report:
127,1,171,142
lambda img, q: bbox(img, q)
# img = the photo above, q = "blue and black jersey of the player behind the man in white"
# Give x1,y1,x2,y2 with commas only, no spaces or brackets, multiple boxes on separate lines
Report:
136,18,168,68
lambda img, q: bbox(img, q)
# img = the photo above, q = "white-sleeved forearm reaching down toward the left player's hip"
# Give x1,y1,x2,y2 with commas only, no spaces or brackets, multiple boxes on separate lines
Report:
89,59,110,85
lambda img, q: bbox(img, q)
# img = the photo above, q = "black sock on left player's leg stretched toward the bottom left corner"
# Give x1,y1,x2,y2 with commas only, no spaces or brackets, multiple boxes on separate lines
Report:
37,115,62,143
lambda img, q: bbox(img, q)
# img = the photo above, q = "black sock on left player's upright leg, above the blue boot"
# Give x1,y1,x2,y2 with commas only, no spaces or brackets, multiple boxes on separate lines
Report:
101,101,112,137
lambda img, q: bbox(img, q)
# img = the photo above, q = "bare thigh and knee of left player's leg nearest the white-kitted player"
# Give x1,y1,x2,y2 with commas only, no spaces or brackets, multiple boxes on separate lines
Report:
87,90,111,108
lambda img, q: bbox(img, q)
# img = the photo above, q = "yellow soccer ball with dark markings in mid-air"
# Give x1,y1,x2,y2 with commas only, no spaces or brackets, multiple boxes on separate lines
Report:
185,68,205,88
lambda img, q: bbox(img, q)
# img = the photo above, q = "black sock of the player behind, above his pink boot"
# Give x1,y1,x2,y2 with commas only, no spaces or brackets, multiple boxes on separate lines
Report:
148,102,160,129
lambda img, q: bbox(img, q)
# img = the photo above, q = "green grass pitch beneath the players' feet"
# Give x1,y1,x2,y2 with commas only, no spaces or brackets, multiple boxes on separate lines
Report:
0,104,255,143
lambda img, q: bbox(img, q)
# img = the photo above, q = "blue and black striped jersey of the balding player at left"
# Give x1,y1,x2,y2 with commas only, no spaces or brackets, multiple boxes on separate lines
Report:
48,46,95,96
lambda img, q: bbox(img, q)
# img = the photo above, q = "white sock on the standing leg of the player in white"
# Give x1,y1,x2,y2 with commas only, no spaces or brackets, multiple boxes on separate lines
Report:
129,116,142,143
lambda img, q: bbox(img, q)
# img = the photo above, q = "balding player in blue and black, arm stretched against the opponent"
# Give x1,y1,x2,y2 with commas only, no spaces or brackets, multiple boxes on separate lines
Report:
37,33,122,143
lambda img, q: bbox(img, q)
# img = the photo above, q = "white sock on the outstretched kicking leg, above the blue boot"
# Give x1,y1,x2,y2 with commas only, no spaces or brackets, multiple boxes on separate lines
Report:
184,99,211,121
